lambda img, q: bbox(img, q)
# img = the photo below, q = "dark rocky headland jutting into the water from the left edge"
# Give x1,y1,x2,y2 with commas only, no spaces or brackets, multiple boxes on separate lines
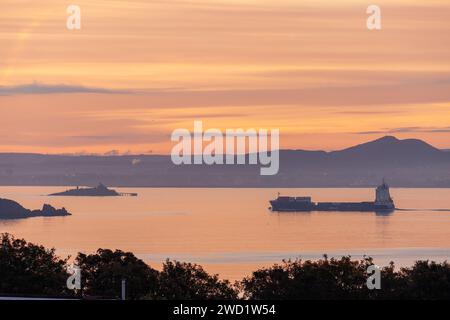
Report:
0,198,71,219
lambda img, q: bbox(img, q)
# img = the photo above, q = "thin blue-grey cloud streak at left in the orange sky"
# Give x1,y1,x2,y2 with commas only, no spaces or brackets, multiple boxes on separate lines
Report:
0,82,132,96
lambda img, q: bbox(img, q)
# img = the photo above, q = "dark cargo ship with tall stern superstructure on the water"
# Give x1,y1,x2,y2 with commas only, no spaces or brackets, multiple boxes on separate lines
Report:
270,179,395,212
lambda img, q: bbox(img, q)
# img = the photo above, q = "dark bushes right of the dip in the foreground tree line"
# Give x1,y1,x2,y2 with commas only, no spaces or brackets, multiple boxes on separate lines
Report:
239,256,450,300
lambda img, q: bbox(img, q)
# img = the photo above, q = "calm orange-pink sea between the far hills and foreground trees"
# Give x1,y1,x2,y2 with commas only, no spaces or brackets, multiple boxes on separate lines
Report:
0,187,450,280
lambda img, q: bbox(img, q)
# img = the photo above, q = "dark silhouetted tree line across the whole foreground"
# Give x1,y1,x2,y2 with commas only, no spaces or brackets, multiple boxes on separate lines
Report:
0,233,450,300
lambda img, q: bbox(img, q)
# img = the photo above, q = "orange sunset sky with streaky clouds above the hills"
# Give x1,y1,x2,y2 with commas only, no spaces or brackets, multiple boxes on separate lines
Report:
0,0,450,154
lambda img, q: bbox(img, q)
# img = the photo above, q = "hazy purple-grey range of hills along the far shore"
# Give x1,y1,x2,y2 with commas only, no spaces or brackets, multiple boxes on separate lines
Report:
0,136,450,187
